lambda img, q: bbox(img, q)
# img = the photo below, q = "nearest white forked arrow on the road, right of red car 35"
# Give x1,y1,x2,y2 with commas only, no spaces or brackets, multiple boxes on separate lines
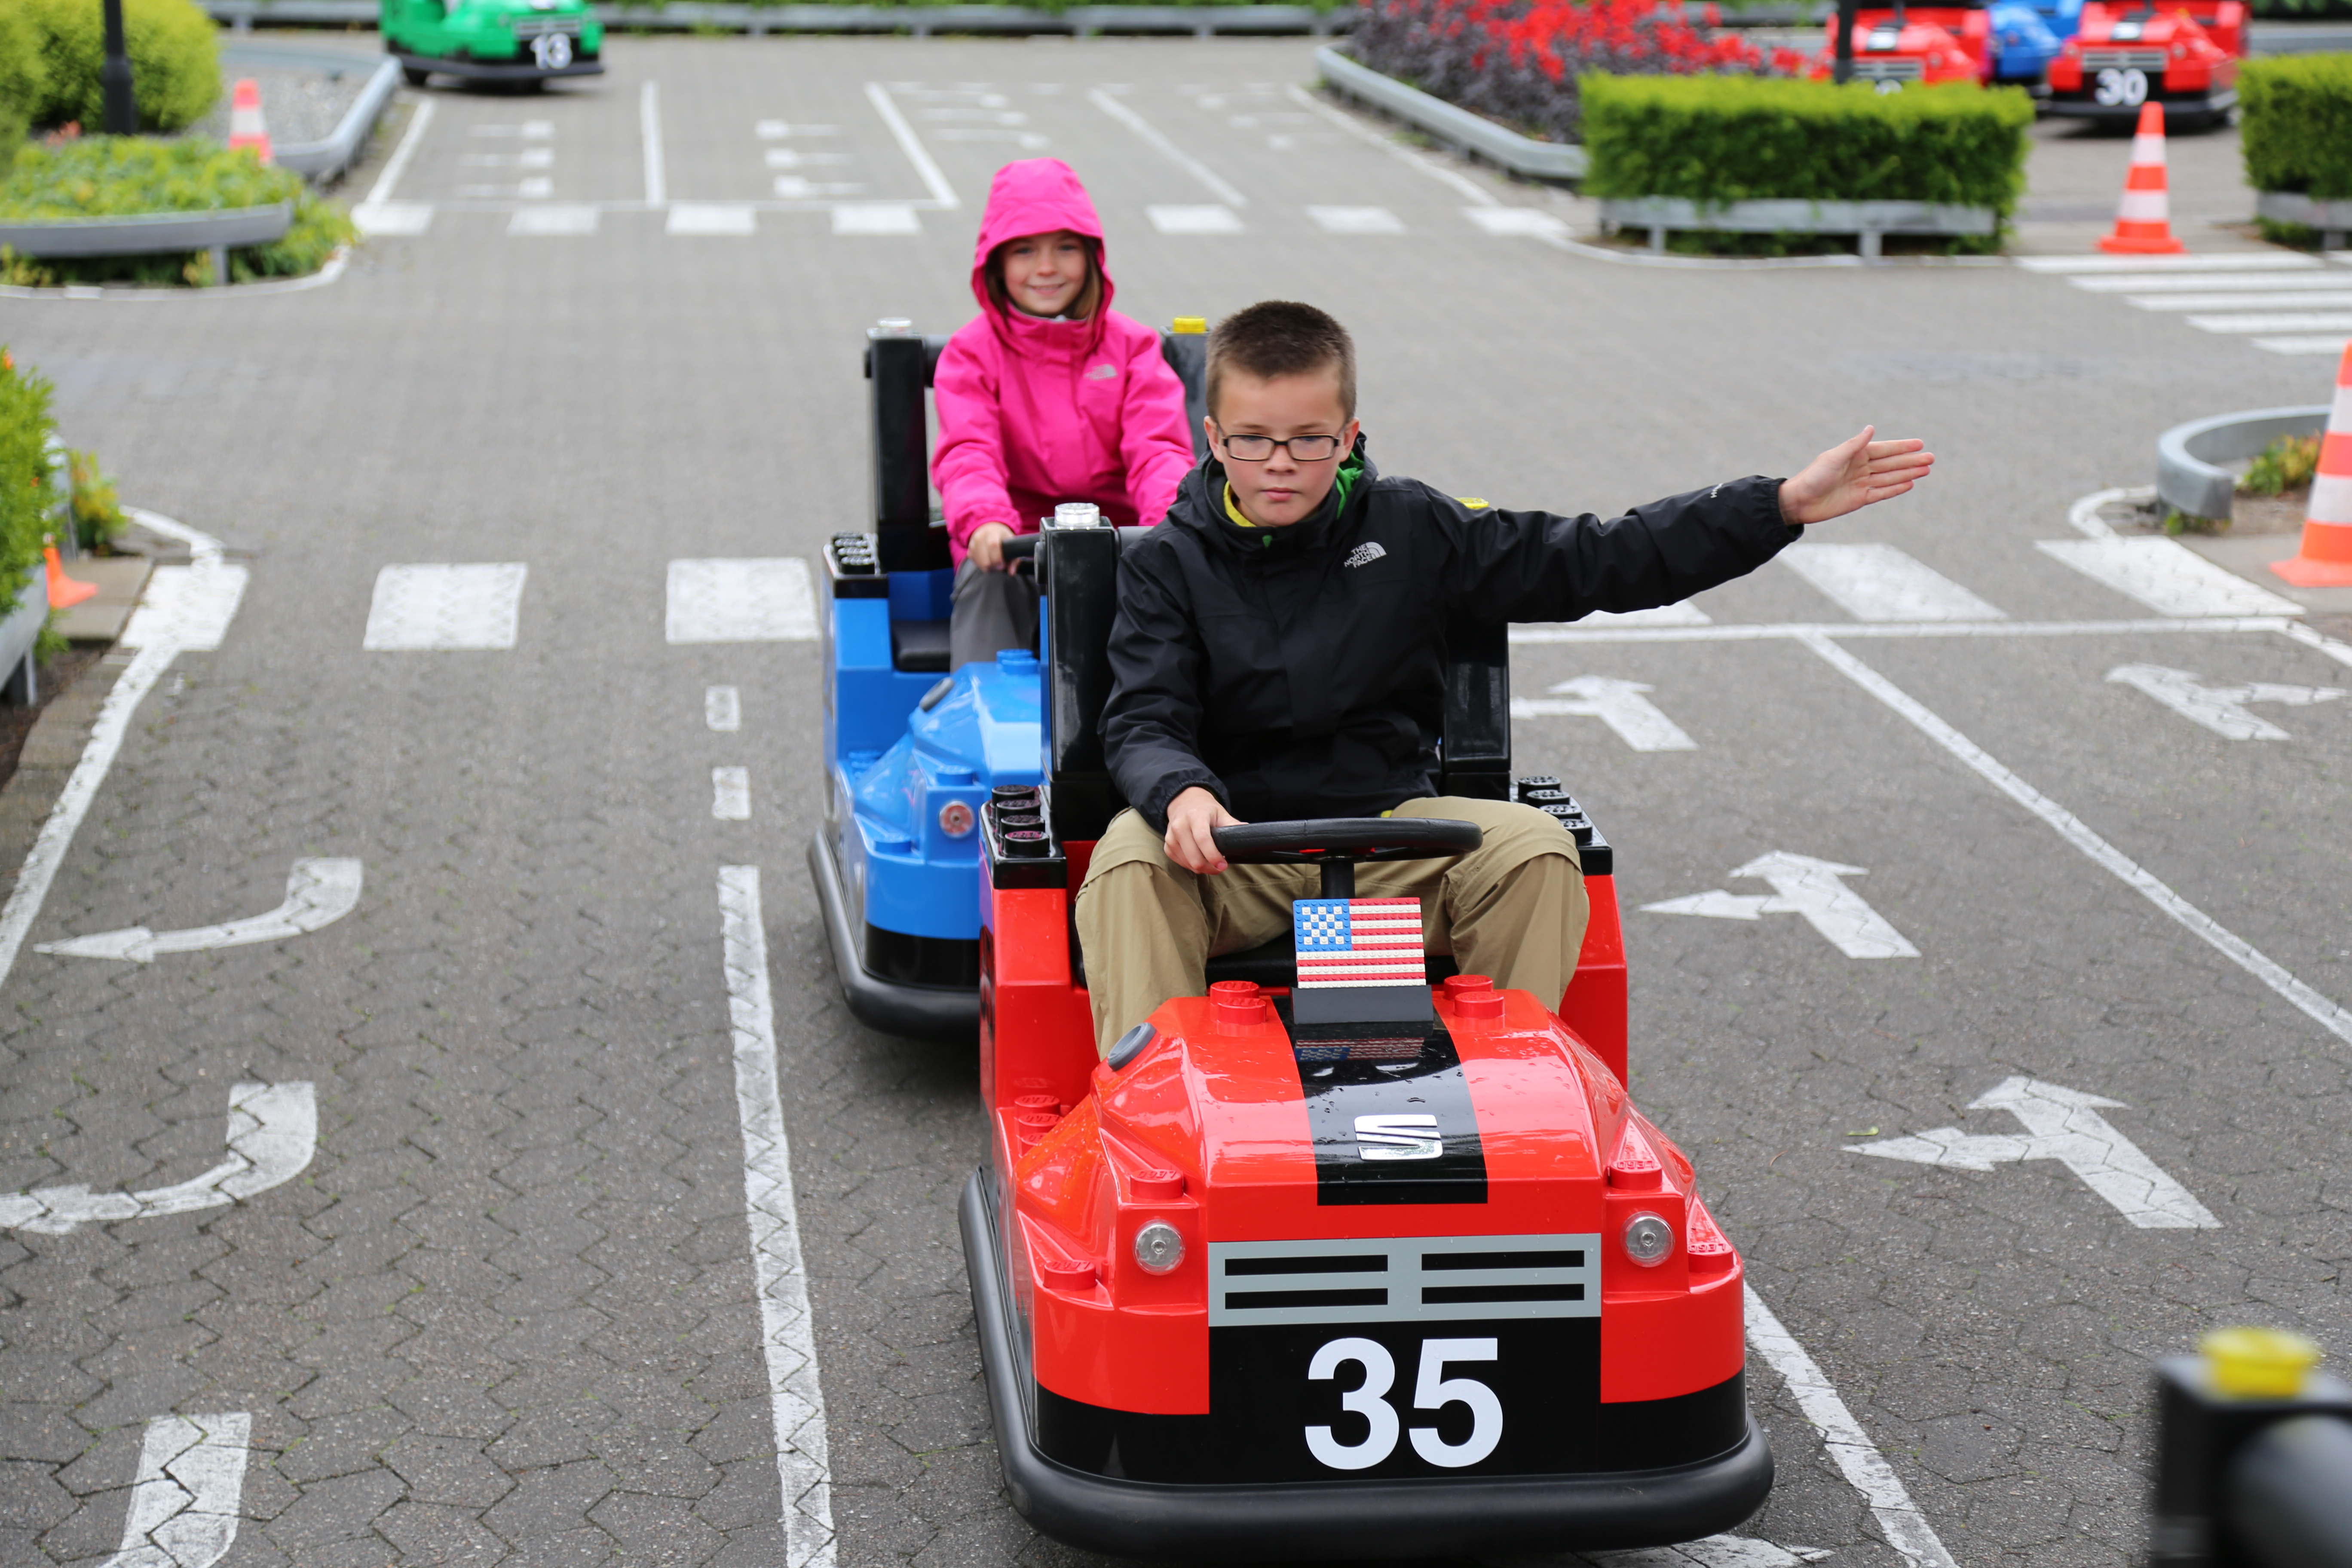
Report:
1849,1079,2220,1229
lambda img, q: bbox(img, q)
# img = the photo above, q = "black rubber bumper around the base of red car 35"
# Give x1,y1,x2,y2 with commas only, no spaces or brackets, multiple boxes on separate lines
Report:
962,1171,1773,1563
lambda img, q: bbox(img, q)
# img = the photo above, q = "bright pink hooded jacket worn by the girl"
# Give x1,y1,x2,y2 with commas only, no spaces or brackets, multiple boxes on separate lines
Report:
931,157,1192,564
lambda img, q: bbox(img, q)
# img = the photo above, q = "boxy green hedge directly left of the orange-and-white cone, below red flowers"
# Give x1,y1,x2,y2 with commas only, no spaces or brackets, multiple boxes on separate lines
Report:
1580,75,2034,219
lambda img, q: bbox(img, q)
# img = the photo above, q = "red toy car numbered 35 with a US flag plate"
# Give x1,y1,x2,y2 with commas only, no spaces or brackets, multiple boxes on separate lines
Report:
962,527,1773,1561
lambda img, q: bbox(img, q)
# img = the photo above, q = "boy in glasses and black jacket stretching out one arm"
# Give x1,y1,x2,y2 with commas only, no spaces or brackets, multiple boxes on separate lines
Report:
1077,301,1936,1051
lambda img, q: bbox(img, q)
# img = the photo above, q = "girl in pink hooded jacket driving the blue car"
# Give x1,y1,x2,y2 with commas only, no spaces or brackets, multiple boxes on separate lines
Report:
931,157,1192,670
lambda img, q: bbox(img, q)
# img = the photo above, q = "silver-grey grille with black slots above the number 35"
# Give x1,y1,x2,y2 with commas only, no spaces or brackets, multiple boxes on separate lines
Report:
1209,1234,1602,1328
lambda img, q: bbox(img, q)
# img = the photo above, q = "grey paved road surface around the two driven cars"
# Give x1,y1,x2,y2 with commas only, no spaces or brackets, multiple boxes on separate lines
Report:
0,40,2352,1568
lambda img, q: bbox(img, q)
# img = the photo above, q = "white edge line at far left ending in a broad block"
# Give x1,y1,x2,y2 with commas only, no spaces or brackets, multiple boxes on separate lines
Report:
0,505,247,1001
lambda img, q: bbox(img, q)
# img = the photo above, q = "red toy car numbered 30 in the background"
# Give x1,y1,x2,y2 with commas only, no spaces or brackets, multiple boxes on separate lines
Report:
2049,0,2246,129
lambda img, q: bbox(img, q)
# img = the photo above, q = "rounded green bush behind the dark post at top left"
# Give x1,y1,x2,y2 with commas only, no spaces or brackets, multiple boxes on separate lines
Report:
26,0,221,132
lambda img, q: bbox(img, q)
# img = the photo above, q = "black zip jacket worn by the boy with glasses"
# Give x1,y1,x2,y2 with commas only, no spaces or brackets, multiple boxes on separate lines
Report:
1103,442,1799,830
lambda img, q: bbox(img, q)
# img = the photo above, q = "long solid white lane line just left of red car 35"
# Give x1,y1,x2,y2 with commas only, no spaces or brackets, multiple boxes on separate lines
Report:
720,865,833,1568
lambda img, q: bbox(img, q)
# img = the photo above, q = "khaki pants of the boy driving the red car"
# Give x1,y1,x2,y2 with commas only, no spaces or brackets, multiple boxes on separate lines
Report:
1077,795,1590,1053
